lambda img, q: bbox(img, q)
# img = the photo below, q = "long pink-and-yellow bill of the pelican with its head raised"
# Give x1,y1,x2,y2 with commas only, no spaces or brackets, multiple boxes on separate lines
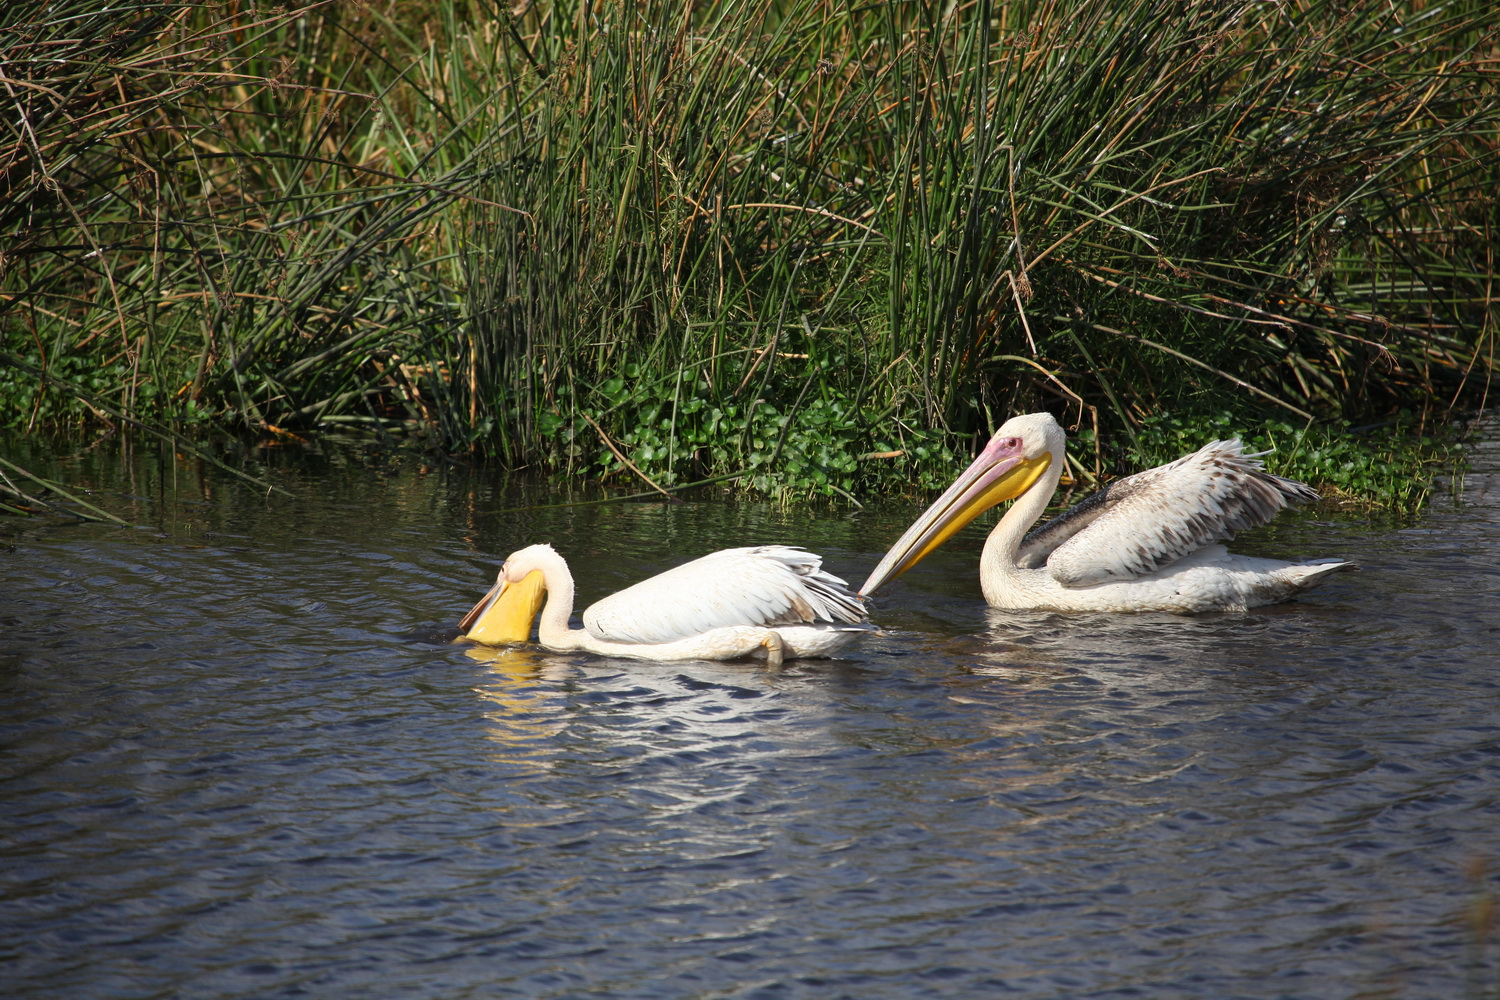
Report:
860,438,1052,595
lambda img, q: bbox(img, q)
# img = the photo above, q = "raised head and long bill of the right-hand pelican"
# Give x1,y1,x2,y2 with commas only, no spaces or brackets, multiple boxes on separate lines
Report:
860,414,1065,595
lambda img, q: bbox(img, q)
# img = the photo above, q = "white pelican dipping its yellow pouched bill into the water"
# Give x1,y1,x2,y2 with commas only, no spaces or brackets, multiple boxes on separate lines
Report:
459,544,873,667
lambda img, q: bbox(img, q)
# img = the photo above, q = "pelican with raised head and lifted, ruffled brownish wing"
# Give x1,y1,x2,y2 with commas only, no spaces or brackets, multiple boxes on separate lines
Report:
860,414,1353,613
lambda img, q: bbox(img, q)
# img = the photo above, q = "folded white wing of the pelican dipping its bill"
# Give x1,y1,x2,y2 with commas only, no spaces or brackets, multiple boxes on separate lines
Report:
584,546,866,643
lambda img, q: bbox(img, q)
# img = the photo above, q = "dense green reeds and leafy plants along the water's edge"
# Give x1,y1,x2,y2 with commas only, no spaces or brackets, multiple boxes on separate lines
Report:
0,0,1500,505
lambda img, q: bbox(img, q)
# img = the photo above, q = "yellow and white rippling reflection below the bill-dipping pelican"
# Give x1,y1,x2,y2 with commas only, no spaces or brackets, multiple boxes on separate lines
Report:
461,643,869,815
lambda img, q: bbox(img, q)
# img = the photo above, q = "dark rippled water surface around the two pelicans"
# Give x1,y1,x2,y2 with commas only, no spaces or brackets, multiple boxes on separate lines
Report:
0,431,1500,1000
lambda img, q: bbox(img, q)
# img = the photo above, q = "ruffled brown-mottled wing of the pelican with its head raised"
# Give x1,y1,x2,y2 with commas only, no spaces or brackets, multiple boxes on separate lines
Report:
1019,441,1317,586
